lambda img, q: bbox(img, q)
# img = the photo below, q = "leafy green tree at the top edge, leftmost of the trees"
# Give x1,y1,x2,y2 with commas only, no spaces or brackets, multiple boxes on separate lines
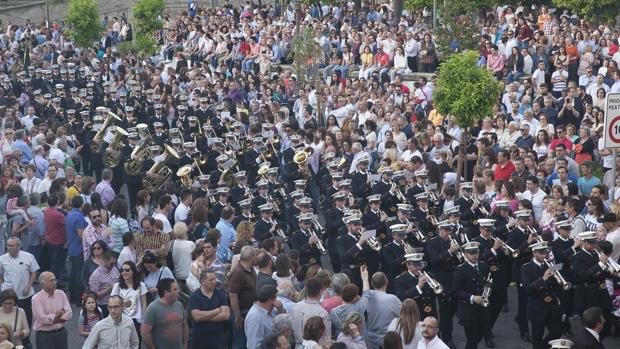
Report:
67,0,103,47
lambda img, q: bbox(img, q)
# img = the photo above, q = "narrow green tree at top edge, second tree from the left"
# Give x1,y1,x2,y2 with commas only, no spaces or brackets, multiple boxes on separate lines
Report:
133,0,165,56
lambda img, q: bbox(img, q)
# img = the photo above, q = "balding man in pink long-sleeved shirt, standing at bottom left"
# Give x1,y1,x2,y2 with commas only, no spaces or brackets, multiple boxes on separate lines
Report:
32,271,72,349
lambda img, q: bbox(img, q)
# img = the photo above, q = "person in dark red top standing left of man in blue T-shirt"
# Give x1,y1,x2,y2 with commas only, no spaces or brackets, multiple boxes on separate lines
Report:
43,193,67,286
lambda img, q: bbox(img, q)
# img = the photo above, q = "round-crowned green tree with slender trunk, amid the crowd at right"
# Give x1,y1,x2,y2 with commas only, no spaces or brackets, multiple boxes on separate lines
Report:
433,51,500,195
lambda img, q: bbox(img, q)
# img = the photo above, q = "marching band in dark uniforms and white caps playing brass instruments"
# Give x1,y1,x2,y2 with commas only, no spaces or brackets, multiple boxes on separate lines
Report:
76,106,619,348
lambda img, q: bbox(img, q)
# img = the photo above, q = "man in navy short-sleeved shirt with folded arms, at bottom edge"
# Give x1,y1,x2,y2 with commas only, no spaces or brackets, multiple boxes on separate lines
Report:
189,269,230,349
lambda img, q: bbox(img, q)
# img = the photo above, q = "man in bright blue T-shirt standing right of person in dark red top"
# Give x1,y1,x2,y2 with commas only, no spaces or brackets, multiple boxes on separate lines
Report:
65,195,88,304
